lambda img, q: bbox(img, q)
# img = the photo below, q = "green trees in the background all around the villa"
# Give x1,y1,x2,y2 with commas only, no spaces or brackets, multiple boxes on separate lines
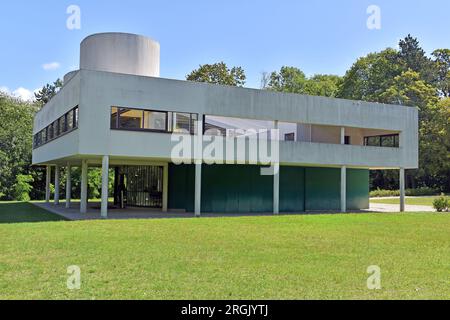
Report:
0,35,450,201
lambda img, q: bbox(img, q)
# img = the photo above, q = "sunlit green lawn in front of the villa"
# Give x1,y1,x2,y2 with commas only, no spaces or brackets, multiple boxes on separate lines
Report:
0,203,450,299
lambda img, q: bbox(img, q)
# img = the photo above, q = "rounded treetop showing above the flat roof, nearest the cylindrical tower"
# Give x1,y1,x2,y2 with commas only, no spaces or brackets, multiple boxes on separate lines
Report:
186,62,247,87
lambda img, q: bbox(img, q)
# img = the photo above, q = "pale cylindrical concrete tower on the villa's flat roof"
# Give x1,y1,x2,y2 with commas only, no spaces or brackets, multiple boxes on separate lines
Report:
80,33,160,77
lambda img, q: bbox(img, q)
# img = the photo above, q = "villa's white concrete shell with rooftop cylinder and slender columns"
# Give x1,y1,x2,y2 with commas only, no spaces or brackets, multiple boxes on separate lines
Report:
33,34,418,216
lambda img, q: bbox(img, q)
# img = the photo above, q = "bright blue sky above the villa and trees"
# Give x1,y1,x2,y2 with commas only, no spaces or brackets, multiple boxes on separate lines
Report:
0,0,450,96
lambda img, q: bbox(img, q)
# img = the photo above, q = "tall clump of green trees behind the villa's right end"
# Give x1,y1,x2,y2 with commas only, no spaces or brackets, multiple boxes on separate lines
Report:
338,35,450,190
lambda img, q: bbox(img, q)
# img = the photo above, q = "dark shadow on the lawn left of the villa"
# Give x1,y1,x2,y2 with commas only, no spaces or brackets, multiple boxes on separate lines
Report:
0,202,66,224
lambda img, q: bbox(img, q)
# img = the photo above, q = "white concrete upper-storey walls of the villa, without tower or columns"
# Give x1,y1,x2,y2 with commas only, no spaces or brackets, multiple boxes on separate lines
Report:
33,70,418,169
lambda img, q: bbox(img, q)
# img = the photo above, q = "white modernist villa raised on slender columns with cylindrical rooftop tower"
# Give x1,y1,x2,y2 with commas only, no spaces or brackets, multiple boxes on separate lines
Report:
33,33,418,217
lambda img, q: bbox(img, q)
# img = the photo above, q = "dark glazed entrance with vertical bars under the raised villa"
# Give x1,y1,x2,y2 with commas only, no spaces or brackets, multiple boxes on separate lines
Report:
122,166,164,209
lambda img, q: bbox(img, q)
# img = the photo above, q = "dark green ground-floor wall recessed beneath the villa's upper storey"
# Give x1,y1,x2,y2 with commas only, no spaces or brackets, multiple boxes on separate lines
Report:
169,165,369,213
